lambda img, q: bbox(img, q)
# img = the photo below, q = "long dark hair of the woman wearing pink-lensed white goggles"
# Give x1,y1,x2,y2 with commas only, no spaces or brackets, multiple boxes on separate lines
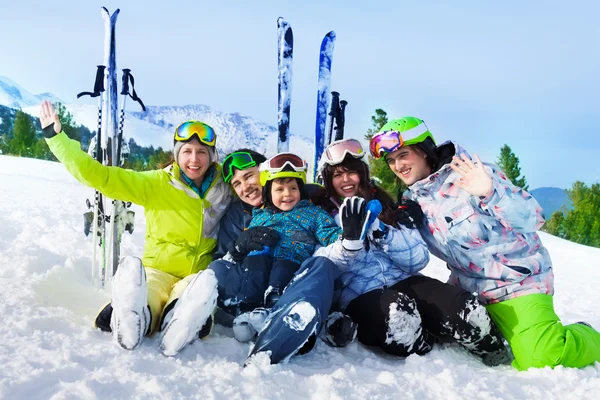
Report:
315,155,396,226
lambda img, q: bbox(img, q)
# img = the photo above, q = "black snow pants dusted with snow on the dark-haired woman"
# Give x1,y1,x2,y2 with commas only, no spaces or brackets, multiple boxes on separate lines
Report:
346,275,509,365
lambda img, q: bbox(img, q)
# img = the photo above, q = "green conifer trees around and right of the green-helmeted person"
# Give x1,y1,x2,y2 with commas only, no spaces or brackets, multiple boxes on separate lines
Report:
365,108,600,247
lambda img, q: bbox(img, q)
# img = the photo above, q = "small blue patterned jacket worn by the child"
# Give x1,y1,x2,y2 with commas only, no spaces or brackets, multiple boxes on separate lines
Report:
248,200,342,264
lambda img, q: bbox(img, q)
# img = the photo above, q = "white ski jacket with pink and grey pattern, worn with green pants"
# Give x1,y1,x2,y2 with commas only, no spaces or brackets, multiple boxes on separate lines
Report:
404,142,554,304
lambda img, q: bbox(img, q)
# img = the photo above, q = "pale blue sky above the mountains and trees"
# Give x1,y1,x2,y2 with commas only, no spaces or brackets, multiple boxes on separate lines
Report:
0,0,600,188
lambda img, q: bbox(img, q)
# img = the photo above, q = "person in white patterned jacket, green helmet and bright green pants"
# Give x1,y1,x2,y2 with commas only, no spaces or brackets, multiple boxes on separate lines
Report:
370,117,600,370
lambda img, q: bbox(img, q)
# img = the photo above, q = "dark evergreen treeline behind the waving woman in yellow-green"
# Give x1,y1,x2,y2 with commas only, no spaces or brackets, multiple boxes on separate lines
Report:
0,103,172,171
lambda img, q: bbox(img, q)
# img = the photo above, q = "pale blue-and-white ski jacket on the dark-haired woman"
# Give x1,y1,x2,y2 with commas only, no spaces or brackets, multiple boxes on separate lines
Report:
315,221,429,311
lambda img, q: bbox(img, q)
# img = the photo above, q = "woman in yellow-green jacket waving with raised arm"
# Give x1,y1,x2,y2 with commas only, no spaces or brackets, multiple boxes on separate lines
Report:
40,101,231,355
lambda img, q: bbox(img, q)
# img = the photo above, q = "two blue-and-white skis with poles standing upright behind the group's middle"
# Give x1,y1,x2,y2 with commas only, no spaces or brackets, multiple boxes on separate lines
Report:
277,17,348,181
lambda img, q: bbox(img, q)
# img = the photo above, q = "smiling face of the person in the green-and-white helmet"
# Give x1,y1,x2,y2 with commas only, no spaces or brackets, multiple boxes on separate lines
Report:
385,146,431,186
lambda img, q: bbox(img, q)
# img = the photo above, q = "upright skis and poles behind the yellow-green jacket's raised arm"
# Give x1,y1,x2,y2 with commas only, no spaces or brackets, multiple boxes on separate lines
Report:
77,7,146,286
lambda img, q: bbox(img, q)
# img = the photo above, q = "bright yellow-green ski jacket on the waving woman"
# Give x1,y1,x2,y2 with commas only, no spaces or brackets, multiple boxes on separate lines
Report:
46,133,231,278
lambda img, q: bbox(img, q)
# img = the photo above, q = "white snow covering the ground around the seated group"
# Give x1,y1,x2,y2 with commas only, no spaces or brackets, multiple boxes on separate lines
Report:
0,156,600,400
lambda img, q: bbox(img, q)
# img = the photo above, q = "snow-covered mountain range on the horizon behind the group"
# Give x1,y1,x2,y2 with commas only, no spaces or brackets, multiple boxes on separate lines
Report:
0,77,314,173
